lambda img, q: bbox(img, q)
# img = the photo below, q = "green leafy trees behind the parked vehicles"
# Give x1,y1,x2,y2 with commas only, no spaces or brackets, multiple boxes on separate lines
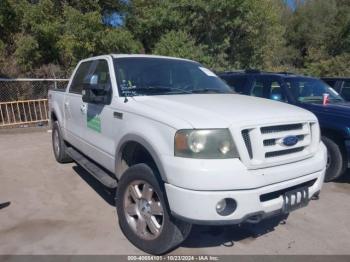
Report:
0,0,350,77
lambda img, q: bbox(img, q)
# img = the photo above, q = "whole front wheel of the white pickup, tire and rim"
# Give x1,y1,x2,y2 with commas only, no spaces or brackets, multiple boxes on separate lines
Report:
116,164,191,255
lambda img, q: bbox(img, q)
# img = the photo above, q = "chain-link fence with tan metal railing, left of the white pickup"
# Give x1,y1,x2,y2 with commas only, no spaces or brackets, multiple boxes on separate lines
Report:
0,78,68,128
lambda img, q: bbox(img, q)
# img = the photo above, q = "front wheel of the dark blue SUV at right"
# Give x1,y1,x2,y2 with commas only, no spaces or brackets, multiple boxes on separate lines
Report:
322,136,346,182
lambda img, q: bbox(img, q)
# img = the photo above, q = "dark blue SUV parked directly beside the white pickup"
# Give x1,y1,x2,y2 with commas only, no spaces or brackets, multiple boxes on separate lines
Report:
218,71,350,181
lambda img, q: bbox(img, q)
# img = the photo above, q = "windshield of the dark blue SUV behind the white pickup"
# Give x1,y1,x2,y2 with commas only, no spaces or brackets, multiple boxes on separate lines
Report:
285,77,344,104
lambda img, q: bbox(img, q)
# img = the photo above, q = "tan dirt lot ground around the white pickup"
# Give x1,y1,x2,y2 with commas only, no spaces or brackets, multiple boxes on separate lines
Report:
0,130,350,255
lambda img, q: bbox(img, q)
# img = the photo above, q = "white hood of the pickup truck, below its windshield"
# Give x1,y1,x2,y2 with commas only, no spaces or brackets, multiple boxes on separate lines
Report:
134,94,316,128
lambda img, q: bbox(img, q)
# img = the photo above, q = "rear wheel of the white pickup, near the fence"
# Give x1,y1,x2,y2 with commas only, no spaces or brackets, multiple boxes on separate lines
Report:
52,121,73,163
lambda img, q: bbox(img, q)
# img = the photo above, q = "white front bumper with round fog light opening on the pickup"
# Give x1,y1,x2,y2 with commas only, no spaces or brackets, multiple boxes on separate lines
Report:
165,170,325,225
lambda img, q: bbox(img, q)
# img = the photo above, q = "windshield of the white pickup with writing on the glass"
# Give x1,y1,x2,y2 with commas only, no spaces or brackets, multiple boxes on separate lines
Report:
114,57,232,96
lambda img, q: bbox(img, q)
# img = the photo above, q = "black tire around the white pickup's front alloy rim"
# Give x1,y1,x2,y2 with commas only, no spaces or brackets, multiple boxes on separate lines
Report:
116,164,191,255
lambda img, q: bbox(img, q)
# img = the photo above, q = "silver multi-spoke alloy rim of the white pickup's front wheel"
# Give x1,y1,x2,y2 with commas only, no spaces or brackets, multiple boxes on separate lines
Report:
124,180,164,240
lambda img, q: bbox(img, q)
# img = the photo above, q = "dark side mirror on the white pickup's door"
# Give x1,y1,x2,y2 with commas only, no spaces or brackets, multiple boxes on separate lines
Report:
82,75,112,105
